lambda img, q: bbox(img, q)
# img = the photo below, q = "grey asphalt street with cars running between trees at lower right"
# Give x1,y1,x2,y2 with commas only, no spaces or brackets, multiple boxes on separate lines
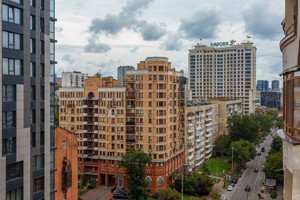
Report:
225,134,273,200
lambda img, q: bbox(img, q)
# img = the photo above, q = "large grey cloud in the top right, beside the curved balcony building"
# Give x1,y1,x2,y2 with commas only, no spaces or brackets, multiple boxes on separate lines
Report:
243,0,284,40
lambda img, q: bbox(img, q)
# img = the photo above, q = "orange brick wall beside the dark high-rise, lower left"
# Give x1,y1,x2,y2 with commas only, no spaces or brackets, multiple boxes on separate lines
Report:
55,127,78,200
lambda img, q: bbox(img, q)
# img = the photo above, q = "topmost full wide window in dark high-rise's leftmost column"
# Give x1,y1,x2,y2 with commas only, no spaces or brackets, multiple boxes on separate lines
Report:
2,4,22,24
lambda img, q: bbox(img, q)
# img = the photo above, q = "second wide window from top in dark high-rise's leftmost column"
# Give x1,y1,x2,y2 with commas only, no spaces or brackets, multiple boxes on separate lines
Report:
2,31,22,50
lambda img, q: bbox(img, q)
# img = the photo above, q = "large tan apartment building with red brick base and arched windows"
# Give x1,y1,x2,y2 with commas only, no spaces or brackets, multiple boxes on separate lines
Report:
59,57,186,192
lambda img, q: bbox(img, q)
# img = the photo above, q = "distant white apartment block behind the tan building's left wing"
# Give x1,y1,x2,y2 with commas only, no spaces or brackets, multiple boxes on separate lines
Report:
62,71,88,87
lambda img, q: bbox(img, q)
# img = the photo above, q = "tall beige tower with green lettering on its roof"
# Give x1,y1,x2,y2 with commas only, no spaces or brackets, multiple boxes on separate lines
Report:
189,40,256,114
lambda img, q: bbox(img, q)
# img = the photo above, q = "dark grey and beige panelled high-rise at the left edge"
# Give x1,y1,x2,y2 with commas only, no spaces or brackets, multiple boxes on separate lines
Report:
0,0,56,200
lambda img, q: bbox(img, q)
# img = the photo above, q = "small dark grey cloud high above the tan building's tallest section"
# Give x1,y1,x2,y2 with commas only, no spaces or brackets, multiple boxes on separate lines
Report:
140,21,167,41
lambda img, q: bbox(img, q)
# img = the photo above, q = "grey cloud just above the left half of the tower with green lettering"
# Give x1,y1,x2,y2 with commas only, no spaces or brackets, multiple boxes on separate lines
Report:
179,8,221,39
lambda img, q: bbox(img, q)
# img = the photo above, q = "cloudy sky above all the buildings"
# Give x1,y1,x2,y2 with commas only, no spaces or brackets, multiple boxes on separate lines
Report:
56,0,284,85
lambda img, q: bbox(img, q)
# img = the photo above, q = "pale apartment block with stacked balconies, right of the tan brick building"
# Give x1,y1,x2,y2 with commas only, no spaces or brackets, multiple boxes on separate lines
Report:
185,102,218,172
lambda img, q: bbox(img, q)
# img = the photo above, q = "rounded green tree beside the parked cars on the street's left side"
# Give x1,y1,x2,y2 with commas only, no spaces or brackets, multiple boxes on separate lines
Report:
231,140,256,170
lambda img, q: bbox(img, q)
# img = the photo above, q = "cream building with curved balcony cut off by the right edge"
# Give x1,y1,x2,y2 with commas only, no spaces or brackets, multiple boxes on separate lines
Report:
278,0,300,200
